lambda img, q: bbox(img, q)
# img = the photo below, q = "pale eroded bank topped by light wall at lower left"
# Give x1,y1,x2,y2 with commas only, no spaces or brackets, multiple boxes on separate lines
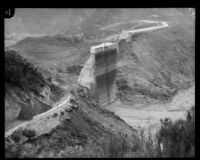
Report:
5,95,73,137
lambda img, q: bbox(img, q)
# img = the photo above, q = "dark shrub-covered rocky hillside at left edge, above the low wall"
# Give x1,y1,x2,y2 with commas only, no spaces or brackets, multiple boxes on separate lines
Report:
5,50,64,126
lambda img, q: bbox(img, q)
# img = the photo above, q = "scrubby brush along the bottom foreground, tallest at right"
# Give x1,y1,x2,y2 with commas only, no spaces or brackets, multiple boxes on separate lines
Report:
5,109,195,158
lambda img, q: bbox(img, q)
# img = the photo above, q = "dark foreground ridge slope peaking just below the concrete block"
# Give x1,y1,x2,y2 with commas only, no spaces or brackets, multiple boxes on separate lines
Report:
6,87,138,158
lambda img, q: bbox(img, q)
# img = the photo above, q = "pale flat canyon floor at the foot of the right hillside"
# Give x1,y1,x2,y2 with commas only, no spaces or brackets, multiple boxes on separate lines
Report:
107,86,195,134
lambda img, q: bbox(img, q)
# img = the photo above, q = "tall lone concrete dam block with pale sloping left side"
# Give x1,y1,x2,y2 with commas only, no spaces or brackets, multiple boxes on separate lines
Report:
78,42,117,106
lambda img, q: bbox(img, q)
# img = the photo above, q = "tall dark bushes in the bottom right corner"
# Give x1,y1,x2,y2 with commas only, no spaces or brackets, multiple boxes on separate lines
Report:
133,108,195,158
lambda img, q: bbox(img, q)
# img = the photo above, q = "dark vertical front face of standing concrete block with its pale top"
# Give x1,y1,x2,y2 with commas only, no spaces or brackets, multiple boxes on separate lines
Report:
93,43,117,106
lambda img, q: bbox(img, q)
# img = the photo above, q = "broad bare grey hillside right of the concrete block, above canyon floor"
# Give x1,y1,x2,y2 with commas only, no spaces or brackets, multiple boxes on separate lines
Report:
117,24,195,103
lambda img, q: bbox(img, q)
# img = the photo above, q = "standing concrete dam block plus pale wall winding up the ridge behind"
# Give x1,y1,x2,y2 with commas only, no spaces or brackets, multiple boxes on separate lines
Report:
78,20,169,106
